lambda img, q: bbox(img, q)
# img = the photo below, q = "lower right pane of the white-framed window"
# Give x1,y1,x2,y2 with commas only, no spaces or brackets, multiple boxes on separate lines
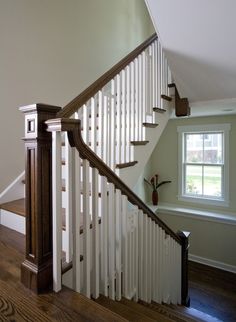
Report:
203,166,222,198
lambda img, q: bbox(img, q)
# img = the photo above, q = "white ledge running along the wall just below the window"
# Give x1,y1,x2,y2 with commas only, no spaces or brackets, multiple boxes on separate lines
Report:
153,203,236,225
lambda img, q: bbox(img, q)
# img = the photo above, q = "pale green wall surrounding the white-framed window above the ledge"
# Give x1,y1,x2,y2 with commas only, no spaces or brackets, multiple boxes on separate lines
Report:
150,115,236,216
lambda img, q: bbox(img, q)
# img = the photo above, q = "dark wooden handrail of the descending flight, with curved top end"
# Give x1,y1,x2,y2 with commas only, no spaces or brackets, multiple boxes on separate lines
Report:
45,118,182,245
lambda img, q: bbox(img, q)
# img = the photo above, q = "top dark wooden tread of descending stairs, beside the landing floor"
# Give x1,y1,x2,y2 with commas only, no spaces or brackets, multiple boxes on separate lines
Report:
96,295,156,322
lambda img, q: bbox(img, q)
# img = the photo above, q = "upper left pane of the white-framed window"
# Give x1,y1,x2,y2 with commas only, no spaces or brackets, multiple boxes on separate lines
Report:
185,134,203,163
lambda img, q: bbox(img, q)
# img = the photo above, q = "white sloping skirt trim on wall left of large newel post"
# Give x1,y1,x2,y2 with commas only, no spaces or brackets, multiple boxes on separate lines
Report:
0,171,25,203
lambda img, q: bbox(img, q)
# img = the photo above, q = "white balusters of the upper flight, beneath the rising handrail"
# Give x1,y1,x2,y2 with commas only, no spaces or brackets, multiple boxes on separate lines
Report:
67,40,171,170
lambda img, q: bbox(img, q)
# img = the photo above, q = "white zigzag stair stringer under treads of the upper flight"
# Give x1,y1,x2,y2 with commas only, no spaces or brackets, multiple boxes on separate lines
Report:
119,103,172,189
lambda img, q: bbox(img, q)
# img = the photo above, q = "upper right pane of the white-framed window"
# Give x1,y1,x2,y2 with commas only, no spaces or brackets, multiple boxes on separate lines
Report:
204,133,223,164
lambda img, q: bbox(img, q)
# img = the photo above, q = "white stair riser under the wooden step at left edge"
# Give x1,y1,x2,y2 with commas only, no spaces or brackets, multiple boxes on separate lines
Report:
0,209,25,235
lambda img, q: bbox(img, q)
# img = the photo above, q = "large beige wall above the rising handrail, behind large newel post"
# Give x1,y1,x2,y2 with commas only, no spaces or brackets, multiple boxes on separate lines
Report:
0,0,154,192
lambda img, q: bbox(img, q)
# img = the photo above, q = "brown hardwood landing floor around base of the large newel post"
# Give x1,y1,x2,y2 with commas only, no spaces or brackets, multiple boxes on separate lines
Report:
0,225,127,322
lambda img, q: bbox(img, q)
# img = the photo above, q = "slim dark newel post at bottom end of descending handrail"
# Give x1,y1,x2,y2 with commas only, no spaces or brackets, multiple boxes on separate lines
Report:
177,231,190,307
